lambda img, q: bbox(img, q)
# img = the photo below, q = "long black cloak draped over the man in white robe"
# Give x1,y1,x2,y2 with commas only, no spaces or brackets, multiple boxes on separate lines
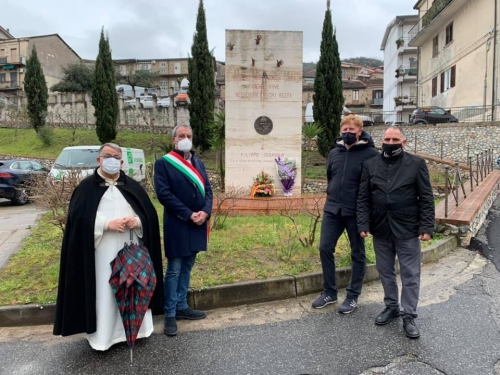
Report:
54,169,163,336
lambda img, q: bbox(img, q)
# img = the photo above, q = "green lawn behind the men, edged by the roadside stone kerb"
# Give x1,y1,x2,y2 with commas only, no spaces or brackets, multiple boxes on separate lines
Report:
0,207,441,306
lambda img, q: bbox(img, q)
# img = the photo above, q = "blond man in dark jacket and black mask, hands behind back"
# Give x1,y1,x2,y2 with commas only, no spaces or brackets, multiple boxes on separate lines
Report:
312,115,378,314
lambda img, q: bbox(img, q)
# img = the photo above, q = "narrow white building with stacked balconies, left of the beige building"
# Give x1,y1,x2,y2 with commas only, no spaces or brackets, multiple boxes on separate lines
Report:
380,15,418,122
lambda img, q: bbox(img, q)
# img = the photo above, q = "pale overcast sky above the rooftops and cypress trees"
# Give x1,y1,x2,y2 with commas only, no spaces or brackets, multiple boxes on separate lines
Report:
0,0,416,62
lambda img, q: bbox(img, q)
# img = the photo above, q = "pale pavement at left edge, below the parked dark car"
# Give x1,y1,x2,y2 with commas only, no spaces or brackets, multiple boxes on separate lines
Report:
0,198,42,270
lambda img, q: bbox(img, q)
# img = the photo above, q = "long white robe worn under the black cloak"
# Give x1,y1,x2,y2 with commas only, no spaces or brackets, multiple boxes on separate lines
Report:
87,179,154,350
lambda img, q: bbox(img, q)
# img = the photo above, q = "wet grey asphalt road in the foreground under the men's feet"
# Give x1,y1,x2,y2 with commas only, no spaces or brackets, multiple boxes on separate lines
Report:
0,245,500,375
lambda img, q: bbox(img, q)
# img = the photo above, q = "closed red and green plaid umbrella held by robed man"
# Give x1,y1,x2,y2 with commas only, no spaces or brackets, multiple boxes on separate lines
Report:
109,230,156,363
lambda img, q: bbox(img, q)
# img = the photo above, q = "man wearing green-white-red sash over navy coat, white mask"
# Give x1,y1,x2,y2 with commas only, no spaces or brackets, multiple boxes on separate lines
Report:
154,125,212,336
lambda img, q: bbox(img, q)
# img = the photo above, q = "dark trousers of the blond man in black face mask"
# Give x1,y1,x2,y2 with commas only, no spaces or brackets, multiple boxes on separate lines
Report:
319,211,366,299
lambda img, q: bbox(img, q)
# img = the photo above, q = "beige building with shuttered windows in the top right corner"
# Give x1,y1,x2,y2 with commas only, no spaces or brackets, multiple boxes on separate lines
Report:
409,0,499,113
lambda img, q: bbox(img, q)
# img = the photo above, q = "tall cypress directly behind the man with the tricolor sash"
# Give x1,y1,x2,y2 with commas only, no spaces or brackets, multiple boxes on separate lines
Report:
188,0,215,151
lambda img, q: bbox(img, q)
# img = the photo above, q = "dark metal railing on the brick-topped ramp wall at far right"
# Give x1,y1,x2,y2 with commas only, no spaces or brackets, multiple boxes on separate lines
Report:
444,149,493,218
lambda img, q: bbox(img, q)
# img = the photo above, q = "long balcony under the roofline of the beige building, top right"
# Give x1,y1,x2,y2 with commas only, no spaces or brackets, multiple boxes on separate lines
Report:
408,0,468,47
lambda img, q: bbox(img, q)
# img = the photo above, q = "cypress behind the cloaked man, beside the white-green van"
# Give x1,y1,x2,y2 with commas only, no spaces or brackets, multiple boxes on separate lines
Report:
92,28,118,143
